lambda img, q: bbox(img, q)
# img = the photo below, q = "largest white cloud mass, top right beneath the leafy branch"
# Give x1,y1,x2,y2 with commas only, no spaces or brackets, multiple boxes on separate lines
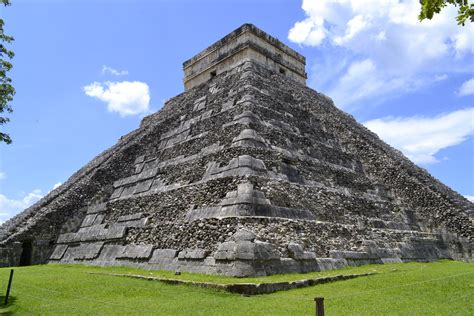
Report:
288,0,474,107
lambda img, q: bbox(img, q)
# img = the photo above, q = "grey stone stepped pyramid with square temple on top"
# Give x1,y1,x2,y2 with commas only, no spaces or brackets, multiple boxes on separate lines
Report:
0,24,474,276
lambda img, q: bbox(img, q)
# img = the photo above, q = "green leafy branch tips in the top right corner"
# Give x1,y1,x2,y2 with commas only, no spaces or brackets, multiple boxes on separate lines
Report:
418,0,474,26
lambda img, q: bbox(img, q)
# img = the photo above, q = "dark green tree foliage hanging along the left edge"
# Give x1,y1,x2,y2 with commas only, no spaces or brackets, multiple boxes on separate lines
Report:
0,0,15,144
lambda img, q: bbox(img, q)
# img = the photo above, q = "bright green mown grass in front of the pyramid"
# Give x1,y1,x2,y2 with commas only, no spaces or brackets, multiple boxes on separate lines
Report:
0,261,474,315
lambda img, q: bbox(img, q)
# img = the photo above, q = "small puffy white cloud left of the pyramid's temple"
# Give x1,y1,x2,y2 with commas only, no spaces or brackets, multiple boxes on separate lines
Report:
84,81,150,117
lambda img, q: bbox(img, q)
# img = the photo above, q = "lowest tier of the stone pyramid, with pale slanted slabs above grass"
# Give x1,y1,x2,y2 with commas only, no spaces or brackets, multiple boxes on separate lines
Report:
49,230,473,277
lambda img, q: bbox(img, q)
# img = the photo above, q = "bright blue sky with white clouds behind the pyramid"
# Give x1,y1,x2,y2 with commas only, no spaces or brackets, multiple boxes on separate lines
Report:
0,0,474,222
